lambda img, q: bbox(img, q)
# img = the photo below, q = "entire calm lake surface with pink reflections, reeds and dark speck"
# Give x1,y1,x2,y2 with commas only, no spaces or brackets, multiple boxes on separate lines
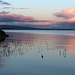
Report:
0,30,75,75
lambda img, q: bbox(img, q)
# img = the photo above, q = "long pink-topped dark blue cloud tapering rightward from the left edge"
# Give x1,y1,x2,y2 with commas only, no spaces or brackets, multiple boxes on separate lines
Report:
0,11,49,22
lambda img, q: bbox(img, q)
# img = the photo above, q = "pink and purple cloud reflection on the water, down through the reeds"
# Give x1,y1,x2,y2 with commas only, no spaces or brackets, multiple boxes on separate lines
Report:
0,32,75,57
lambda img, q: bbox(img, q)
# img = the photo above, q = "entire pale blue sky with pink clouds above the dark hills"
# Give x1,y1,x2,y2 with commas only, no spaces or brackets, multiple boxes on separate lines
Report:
0,0,75,28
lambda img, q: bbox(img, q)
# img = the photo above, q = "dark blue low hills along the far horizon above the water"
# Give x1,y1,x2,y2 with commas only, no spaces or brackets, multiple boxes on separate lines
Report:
0,25,75,30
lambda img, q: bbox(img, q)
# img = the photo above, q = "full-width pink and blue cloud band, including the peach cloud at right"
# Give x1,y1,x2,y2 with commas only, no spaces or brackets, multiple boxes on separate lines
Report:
0,7,75,29
